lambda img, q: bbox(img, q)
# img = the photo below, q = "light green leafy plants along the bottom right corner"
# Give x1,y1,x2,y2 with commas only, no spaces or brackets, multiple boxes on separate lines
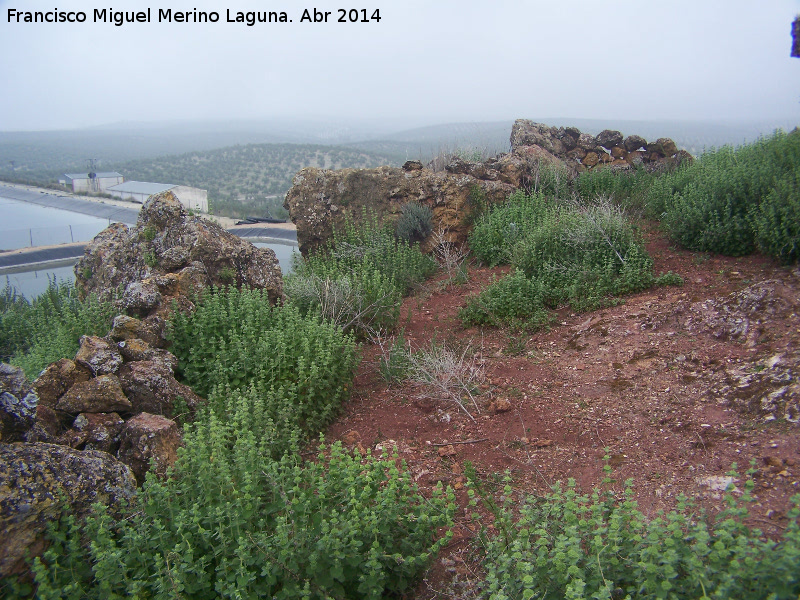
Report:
469,468,800,600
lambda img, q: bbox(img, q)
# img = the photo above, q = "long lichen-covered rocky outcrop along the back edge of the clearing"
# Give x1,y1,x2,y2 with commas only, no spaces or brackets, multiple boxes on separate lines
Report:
284,119,691,255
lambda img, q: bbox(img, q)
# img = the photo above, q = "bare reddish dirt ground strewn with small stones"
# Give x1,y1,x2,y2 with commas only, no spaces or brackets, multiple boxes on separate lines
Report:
327,230,800,598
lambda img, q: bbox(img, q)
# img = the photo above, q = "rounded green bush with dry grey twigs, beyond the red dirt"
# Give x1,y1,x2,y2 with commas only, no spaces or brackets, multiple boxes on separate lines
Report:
461,194,677,328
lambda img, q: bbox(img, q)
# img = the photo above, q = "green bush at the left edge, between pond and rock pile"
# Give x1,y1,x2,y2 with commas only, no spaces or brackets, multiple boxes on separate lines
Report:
0,281,116,379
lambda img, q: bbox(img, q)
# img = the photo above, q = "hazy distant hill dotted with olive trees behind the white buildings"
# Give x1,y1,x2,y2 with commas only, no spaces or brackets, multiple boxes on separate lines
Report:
114,144,397,217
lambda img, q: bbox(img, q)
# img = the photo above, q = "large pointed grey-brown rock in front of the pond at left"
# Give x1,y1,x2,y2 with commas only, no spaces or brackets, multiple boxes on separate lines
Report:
75,192,283,304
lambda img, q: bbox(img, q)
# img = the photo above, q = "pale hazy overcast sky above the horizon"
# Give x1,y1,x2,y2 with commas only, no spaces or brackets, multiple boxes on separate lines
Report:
0,0,800,131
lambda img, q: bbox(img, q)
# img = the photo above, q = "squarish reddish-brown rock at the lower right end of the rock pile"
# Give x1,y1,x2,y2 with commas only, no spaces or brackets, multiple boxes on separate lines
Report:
117,413,181,483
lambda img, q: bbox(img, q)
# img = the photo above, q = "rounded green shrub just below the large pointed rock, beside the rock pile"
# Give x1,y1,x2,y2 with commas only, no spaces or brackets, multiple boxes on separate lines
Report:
171,288,357,434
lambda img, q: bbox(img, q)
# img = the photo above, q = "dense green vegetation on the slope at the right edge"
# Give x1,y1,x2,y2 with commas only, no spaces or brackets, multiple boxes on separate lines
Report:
576,132,800,263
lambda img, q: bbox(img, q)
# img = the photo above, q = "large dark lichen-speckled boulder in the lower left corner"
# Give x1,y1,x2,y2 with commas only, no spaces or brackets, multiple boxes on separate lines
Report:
0,443,136,578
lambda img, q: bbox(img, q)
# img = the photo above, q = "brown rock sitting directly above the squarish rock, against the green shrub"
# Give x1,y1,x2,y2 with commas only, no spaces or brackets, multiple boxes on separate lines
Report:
119,360,203,417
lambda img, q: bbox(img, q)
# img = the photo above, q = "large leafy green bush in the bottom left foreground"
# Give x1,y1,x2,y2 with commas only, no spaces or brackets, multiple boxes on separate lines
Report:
29,396,454,600
